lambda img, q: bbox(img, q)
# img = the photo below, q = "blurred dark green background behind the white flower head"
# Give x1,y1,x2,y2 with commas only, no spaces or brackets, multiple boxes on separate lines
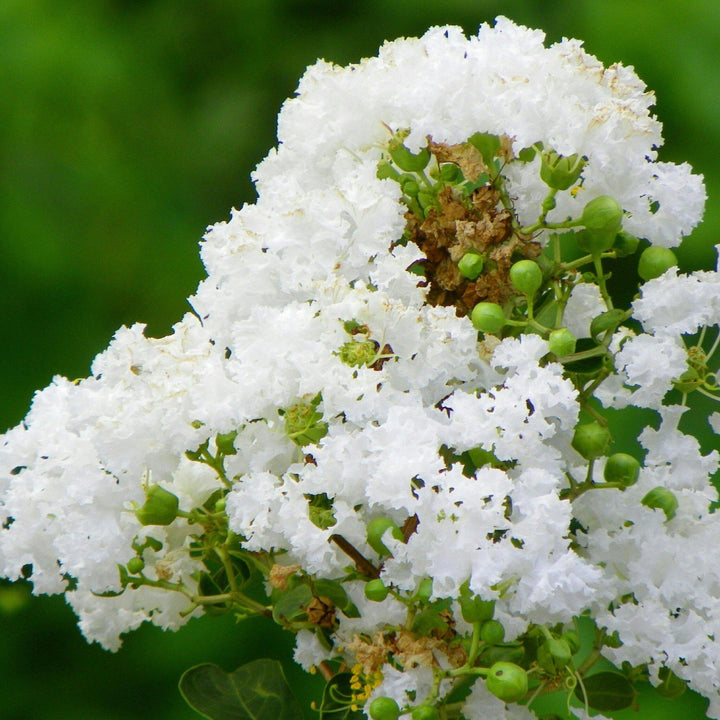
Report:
0,0,720,720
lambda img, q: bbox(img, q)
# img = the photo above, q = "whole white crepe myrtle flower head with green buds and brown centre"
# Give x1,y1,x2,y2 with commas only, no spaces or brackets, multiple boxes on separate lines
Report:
0,18,720,720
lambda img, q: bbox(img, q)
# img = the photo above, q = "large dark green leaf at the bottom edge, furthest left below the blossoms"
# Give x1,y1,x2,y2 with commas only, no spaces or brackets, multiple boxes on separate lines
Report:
179,659,303,720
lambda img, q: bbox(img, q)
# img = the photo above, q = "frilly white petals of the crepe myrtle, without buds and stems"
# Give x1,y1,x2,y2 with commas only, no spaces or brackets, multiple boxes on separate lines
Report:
0,18,720,720
